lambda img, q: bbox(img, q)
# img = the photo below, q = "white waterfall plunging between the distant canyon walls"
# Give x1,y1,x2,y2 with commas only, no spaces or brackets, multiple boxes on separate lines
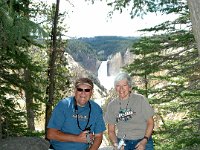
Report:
98,61,114,90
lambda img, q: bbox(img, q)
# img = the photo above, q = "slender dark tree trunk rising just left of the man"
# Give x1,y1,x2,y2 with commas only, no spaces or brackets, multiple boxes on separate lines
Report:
45,0,60,138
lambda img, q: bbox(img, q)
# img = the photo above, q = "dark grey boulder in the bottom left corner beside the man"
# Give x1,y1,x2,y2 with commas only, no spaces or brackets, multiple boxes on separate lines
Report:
0,137,50,150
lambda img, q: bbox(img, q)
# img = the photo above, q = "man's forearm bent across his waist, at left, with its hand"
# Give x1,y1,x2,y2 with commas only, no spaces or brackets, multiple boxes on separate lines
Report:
47,128,87,143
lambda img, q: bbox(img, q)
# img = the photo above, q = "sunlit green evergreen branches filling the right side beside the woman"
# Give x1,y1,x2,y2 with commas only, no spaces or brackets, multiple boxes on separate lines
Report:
124,5,200,150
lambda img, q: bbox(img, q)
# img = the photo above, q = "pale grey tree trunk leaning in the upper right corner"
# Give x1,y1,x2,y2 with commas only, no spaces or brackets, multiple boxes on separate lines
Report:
187,0,200,57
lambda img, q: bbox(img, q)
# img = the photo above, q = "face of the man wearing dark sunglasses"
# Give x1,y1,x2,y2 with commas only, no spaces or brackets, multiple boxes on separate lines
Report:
75,84,93,106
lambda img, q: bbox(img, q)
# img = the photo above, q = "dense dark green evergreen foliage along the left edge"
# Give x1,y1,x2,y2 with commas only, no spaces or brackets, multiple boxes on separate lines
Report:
0,1,48,138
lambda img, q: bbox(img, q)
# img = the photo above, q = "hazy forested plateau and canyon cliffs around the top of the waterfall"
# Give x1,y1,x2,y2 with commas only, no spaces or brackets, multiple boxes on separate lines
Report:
66,36,138,76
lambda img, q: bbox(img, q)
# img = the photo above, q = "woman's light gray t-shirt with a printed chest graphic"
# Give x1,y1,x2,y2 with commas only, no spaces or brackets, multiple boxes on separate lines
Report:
105,94,154,140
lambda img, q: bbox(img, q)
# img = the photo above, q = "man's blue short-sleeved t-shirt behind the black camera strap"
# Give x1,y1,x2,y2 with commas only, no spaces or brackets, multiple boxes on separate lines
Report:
47,97,106,150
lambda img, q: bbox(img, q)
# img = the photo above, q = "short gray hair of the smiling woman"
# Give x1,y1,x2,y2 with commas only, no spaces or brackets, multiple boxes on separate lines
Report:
114,72,132,87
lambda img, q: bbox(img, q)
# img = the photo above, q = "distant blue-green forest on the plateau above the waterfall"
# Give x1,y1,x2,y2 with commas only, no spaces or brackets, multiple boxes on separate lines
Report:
67,36,139,61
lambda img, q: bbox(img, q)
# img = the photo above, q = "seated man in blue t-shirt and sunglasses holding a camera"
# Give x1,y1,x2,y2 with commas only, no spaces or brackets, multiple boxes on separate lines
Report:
47,78,106,150
